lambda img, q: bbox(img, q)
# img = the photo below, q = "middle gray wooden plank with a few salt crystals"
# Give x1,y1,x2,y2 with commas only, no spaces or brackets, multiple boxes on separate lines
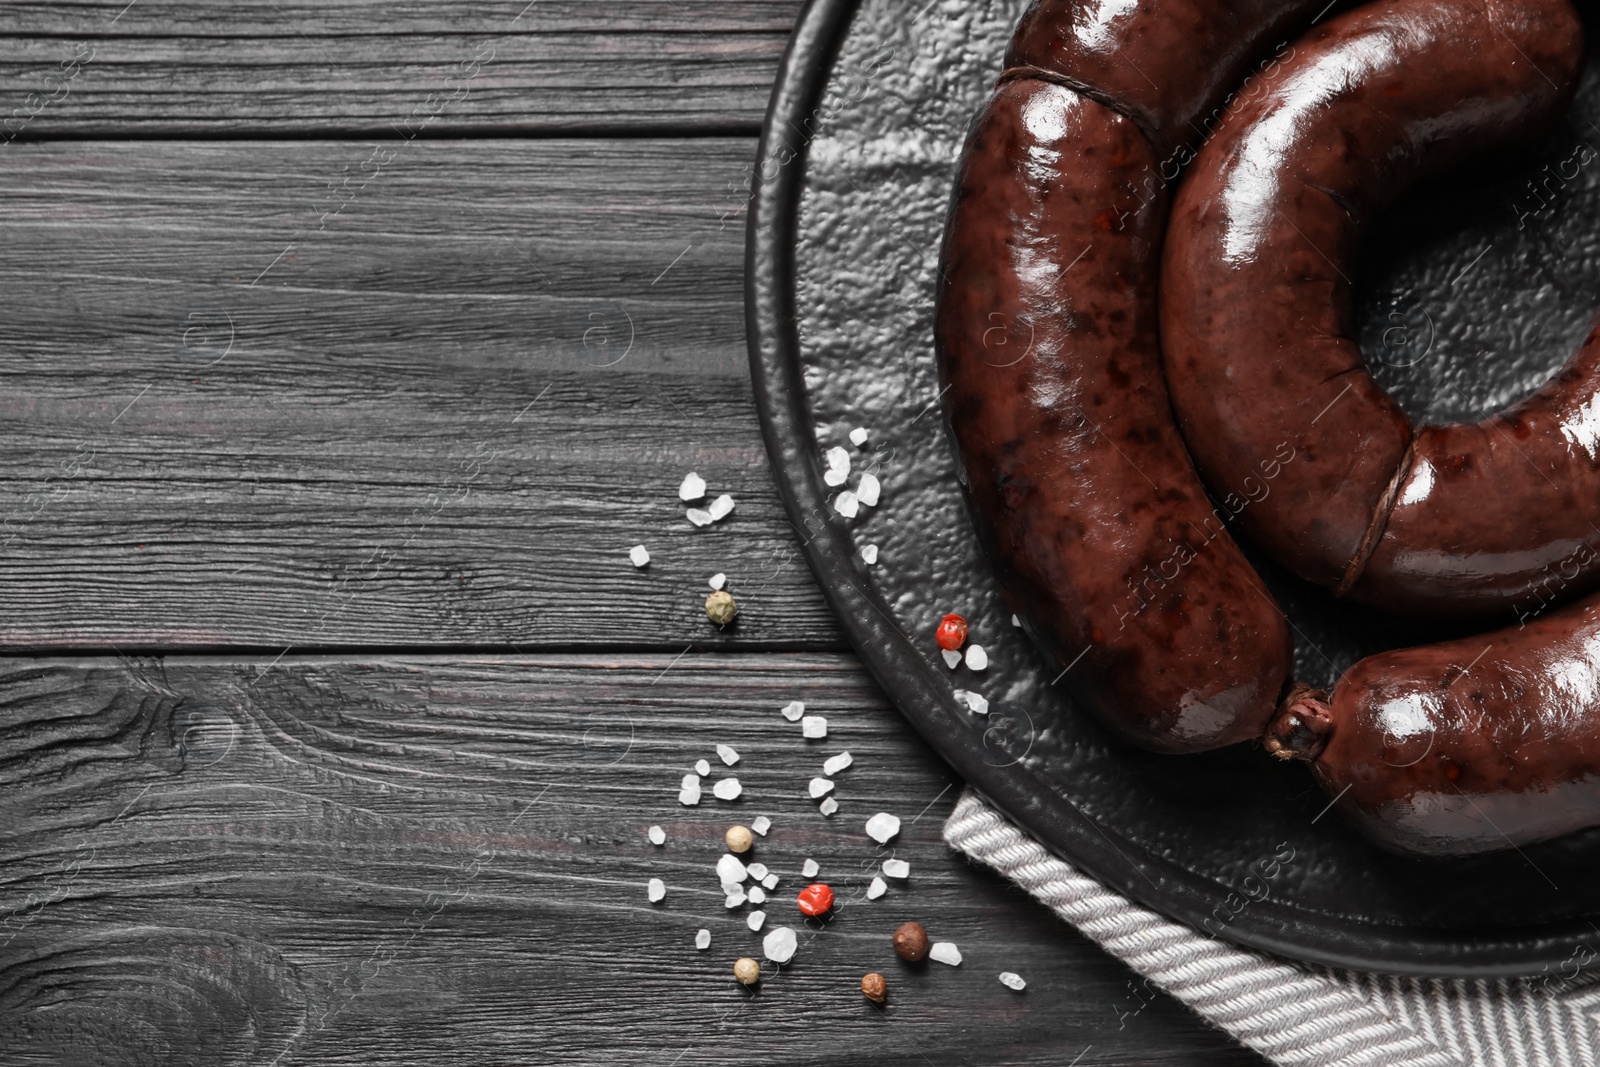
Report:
0,139,840,649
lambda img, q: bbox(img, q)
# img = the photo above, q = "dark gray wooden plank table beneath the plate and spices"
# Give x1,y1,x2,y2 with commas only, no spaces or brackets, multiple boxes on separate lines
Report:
0,0,1261,1067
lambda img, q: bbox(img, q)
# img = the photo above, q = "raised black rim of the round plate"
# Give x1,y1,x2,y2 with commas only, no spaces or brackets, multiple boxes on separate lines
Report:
744,0,1595,979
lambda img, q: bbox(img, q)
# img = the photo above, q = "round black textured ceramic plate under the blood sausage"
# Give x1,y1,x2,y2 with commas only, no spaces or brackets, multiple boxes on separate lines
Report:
747,0,1600,976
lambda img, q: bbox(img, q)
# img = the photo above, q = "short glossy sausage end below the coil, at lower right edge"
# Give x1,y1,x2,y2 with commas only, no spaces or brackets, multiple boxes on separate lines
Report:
1269,595,1600,856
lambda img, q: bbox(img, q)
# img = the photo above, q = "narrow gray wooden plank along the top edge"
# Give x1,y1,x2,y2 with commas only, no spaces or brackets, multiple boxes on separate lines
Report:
0,0,800,139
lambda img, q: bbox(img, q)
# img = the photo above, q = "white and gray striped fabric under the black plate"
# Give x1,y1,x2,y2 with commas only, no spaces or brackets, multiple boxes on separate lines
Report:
944,790,1600,1067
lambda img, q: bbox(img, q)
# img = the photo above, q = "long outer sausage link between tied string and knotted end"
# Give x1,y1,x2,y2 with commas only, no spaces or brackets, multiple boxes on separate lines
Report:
936,80,1290,752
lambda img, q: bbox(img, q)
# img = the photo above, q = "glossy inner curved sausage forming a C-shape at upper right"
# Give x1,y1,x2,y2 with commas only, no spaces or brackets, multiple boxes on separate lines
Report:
1162,0,1600,601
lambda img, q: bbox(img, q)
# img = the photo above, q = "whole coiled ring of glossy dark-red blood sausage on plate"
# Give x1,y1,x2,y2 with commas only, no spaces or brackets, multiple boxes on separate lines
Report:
936,0,1600,853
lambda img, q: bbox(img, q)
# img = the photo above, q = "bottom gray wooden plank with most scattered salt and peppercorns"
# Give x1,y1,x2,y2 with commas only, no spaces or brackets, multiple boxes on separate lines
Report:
0,654,1261,1067
